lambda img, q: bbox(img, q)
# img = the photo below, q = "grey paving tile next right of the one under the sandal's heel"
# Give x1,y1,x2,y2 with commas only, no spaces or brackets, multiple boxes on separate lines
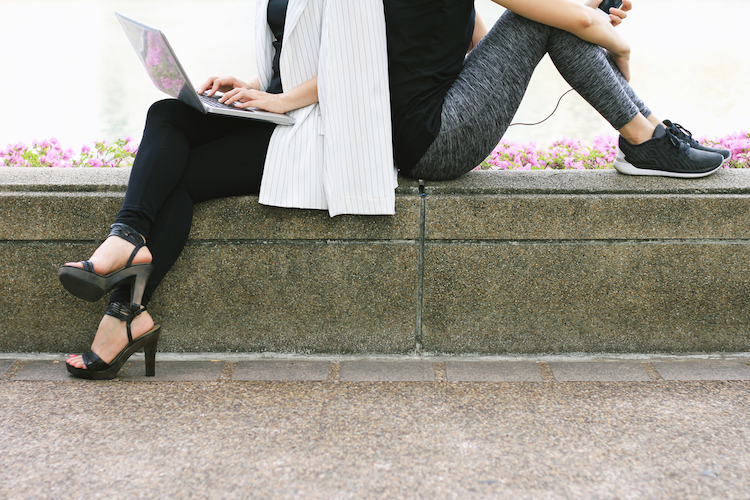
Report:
232,360,331,382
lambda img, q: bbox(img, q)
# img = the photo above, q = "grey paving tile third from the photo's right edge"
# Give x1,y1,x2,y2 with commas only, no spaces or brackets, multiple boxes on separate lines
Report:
445,361,542,382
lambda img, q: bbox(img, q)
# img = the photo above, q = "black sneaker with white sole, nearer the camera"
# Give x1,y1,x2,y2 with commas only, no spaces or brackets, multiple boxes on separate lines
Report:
614,124,724,178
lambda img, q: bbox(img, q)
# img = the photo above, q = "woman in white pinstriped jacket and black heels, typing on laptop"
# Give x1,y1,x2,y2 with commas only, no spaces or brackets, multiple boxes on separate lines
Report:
58,0,396,379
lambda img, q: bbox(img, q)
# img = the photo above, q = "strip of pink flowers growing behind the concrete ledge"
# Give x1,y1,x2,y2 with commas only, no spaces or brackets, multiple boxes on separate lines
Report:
0,131,750,170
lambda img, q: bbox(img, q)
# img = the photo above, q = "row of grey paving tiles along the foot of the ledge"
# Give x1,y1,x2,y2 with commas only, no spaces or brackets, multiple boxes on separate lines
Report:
0,354,750,383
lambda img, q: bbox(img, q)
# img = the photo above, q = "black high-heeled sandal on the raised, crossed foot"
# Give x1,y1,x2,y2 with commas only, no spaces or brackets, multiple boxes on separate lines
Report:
57,223,154,304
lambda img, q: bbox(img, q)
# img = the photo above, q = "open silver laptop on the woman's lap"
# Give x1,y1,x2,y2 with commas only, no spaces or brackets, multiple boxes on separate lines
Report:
115,12,294,125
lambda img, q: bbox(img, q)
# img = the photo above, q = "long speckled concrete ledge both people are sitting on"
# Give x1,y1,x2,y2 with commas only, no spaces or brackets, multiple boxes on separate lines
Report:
0,168,750,354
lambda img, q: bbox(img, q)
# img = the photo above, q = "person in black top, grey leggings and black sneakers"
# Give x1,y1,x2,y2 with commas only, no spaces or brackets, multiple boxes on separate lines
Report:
384,0,730,180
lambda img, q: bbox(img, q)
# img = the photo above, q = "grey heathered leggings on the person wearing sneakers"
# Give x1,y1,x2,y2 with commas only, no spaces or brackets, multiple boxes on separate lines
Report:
409,11,651,181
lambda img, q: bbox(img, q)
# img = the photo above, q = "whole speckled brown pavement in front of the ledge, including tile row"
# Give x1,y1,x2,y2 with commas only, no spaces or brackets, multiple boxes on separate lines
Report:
0,354,750,499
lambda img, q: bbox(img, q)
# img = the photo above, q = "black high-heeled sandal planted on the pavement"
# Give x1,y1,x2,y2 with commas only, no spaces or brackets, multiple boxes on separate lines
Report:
66,302,161,380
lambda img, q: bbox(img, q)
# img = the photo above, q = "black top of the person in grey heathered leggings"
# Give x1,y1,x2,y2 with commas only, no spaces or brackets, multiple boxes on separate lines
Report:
384,0,475,172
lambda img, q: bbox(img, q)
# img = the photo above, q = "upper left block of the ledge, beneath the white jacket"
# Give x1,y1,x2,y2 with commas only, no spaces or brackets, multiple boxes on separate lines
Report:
0,168,419,242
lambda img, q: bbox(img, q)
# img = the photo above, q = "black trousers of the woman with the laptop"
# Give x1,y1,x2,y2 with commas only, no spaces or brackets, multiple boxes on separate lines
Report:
110,99,275,305
